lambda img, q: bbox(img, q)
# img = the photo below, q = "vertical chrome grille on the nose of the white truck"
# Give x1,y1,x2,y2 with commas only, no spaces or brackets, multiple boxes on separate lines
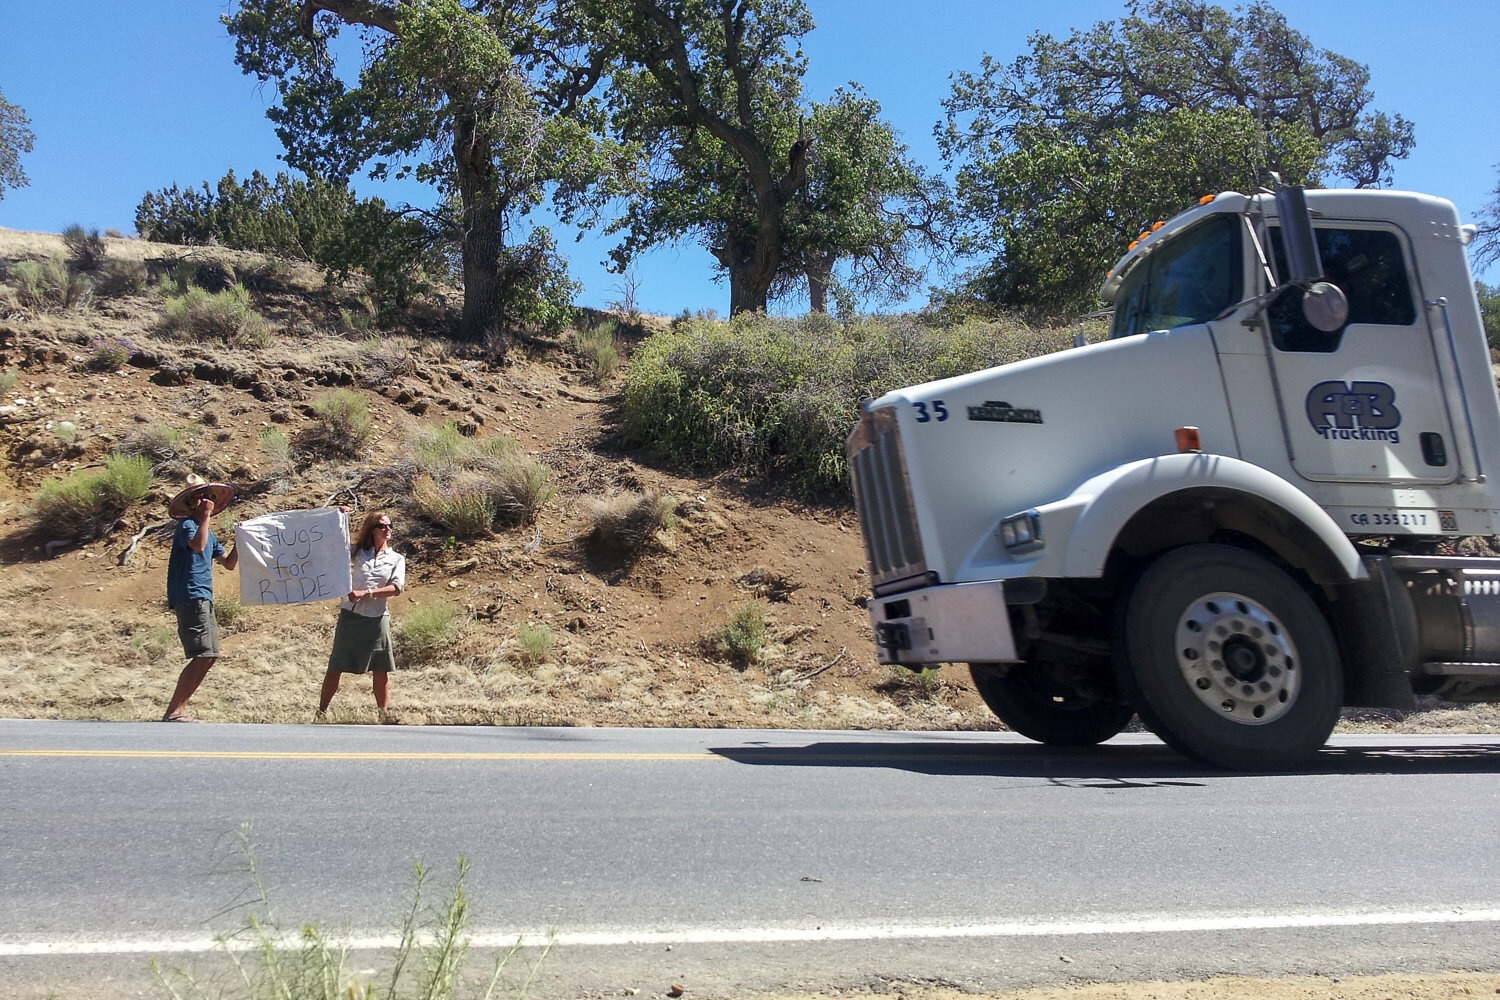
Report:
849,408,927,591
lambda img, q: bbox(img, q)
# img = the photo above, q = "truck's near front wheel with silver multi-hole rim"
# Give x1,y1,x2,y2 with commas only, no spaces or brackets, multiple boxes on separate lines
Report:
1113,544,1344,771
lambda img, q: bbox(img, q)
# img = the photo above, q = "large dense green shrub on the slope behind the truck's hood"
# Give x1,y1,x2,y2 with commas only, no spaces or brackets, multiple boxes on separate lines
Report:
621,315,1070,495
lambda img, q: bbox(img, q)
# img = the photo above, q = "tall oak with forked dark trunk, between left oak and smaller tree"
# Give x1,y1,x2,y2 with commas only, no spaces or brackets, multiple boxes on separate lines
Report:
590,0,813,313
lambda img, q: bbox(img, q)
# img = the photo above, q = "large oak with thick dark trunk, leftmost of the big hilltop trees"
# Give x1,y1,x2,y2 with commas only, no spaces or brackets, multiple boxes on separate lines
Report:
225,0,608,342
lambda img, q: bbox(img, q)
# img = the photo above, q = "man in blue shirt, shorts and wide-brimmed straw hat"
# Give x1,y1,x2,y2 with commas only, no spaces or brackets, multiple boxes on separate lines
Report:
162,492,240,723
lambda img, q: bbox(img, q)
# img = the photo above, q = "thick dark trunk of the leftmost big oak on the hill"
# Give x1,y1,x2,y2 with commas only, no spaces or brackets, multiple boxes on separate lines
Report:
453,118,506,346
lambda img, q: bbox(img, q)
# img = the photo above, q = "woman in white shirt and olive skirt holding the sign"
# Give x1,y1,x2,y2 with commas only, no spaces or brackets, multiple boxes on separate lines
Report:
314,510,407,723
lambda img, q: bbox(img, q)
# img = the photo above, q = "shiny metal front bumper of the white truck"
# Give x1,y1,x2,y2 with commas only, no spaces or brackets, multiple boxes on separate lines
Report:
869,580,1016,664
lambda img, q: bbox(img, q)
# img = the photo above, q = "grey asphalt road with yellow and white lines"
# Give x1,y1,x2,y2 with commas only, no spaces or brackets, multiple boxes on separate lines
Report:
0,720,1500,997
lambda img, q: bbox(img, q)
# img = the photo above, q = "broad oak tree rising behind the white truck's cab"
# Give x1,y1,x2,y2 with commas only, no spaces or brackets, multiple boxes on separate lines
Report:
939,0,1413,312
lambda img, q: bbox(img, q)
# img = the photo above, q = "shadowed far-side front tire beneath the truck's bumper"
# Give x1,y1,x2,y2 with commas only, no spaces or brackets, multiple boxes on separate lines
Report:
969,663,1136,747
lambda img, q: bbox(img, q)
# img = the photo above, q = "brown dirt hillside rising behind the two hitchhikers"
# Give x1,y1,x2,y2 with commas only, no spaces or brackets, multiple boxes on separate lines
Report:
0,229,1500,732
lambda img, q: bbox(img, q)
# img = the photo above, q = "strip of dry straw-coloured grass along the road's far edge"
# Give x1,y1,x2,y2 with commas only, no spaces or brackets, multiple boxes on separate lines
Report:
0,570,993,729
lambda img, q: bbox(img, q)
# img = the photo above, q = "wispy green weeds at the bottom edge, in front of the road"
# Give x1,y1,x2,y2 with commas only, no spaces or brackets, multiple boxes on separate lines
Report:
152,831,551,1000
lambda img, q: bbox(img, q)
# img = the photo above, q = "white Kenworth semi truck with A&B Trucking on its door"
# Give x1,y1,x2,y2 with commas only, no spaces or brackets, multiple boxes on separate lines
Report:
849,186,1500,769
